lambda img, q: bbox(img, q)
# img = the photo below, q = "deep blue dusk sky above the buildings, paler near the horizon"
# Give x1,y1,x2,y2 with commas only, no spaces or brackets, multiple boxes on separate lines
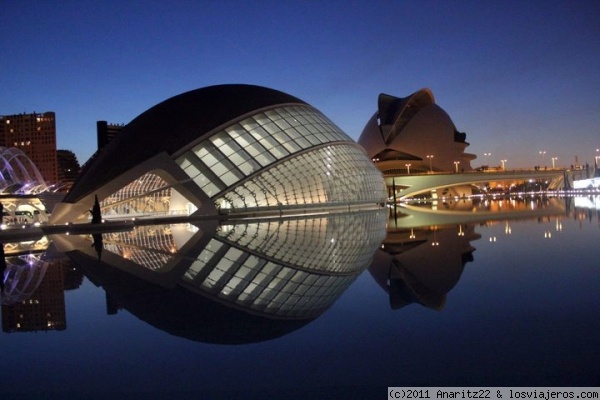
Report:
0,0,600,168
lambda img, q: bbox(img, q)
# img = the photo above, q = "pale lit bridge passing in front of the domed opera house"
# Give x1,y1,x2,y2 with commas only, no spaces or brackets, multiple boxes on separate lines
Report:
384,169,573,200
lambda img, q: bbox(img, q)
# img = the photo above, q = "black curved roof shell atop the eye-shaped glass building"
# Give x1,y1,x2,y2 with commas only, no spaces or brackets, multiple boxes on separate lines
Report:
64,84,307,202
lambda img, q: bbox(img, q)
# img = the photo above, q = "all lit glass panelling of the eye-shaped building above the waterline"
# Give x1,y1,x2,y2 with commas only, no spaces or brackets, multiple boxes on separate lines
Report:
95,105,387,222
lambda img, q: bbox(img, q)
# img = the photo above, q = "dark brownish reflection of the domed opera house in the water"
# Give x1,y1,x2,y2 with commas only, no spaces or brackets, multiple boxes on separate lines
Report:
369,217,481,310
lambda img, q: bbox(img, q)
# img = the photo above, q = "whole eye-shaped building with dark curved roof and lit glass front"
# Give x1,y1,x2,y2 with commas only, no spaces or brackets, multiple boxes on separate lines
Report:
51,84,386,223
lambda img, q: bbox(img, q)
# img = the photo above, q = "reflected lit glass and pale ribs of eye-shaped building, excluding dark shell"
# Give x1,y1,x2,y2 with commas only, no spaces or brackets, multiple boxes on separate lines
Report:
52,210,387,330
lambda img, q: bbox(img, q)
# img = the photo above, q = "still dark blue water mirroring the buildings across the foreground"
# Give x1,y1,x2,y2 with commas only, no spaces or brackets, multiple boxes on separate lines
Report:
0,198,600,399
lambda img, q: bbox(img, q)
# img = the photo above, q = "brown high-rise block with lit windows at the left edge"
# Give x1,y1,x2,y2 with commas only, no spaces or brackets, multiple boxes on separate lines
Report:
0,111,58,183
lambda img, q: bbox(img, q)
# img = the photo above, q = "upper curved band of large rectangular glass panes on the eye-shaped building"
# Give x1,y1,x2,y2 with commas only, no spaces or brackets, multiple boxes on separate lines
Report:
177,105,358,204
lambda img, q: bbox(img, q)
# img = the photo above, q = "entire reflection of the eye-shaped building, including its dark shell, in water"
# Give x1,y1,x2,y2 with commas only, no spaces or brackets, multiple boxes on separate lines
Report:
52,210,386,343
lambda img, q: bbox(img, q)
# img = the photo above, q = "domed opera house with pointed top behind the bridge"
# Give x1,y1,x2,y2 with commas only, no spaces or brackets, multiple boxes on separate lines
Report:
358,89,475,177
